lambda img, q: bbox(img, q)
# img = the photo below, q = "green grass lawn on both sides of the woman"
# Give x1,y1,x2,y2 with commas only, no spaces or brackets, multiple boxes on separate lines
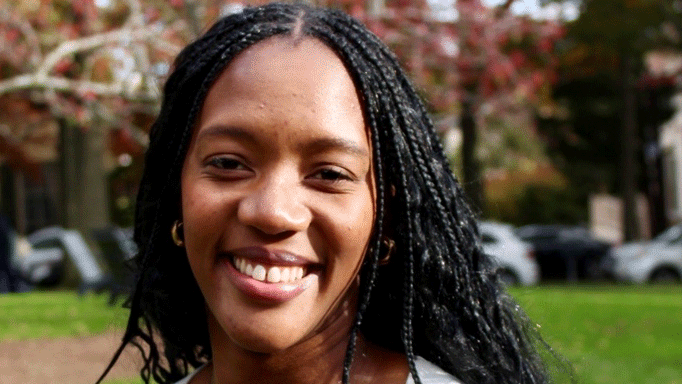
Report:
0,285,682,384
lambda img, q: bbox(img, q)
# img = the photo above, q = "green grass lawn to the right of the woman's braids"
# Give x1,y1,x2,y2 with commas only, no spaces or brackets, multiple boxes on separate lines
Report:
511,285,682,384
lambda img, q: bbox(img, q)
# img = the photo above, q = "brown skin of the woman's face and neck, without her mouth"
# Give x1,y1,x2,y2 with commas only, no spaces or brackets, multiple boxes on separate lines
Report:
181,37,408,384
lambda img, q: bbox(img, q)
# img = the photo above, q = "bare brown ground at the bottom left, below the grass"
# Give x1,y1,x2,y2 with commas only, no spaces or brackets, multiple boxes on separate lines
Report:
0,332,140,384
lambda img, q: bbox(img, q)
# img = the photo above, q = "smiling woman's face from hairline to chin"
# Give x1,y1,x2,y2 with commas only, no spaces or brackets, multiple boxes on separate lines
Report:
182,37,375,352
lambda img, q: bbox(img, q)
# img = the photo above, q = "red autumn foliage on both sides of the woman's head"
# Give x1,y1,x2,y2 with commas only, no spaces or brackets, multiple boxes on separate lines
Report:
0,0,563,174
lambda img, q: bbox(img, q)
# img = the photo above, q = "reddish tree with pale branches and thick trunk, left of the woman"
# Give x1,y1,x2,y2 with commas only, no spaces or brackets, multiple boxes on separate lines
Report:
0,0,239,231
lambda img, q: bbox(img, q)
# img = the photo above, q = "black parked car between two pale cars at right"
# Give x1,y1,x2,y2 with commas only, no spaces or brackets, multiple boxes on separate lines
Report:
516,224,611,281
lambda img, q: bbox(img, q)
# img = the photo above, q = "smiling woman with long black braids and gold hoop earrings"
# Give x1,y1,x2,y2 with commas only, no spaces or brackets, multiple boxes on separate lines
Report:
98,4,564,384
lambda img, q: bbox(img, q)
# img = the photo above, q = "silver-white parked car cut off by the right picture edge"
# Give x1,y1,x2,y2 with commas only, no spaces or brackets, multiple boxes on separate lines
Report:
604,224,682,283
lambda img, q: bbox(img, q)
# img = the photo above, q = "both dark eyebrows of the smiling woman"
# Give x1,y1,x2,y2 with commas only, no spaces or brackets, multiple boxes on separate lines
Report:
197,125,369,157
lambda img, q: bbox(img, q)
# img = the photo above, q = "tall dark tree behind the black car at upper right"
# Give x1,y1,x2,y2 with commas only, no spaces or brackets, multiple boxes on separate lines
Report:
543,0,680,239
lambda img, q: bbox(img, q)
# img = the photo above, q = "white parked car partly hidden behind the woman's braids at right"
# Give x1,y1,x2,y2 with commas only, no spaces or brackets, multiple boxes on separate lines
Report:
479,221,539,285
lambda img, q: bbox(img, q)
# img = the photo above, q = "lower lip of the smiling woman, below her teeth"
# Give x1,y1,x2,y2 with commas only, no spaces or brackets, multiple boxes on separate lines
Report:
221,260,316,304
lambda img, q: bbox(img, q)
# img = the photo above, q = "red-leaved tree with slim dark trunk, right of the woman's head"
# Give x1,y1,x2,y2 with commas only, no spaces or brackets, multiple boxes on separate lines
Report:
355,0,563,209
